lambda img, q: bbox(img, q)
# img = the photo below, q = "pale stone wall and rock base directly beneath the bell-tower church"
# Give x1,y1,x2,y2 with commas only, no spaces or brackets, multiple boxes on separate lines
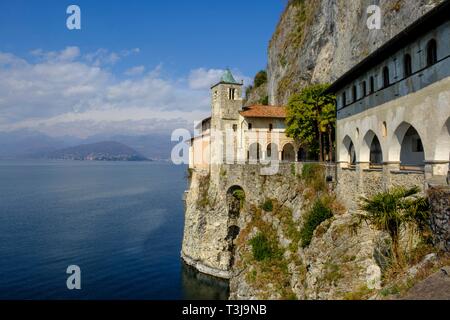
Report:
181,163,301,278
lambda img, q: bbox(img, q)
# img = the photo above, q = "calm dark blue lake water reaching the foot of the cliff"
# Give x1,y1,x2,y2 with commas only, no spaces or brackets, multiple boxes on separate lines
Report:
0,161,228,299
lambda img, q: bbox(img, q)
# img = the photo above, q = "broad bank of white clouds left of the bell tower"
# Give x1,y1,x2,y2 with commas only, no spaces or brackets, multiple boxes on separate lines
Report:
0,47,250,137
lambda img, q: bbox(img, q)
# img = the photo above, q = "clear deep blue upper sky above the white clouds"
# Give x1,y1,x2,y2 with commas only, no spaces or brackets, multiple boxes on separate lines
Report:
0,0,285,76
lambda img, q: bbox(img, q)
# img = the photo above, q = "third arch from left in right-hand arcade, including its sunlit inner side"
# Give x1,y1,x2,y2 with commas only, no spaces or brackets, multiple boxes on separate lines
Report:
389,122,425,167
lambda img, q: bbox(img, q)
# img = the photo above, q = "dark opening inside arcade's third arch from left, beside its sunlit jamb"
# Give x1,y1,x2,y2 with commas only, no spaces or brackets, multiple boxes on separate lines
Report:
395,122,425,170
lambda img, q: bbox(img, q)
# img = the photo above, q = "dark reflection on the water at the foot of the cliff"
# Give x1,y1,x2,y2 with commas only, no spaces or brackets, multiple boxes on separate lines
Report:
181,262,230,300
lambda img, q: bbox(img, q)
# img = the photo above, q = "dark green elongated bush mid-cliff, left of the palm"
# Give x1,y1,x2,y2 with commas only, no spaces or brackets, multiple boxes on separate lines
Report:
300,199,333,248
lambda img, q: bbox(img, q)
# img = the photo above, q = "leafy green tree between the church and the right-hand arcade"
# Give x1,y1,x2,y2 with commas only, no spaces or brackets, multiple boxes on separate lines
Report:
286,84,336,161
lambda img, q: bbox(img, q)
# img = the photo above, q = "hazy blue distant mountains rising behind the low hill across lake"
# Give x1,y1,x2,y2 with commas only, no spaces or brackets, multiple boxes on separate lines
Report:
0,130,177,160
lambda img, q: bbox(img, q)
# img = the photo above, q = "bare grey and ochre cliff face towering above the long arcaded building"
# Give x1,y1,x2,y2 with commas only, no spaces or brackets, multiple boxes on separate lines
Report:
267,0,442,105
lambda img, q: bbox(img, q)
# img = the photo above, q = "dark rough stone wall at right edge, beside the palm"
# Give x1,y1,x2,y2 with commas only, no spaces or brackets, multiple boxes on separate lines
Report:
428,187,450,251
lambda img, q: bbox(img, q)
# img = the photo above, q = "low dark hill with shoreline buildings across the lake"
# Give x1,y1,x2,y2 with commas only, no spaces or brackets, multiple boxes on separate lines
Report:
34,141,148,161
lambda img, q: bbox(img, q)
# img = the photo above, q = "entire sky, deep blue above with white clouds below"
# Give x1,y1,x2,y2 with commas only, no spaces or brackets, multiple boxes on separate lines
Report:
0,0,286,137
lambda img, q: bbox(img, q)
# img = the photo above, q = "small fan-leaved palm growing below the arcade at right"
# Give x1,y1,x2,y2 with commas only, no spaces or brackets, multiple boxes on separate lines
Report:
360,187,429,263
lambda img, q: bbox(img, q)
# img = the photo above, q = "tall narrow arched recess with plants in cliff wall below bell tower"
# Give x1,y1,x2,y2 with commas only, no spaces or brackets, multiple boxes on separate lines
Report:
225,186,245,268
